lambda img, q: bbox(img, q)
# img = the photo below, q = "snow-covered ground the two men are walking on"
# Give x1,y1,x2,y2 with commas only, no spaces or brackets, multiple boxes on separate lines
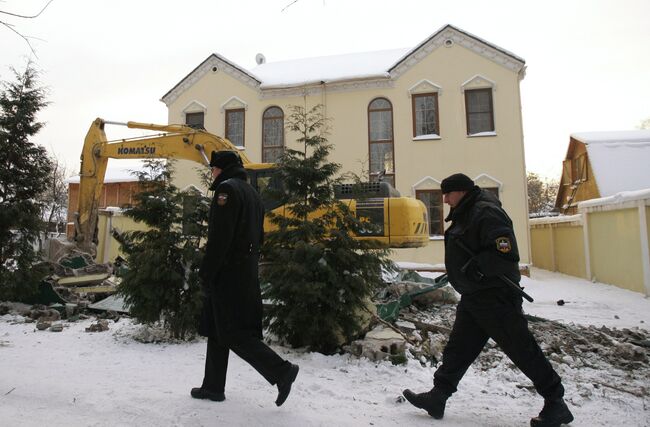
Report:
0,269,650,427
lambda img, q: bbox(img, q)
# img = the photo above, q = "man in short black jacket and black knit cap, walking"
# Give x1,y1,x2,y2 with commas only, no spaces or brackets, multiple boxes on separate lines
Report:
404,173,573,427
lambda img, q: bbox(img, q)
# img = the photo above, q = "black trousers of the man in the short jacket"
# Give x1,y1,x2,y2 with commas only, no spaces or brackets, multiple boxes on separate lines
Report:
433,288,564,399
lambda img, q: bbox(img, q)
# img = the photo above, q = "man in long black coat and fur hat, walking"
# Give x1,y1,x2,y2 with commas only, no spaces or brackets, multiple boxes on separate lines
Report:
191,151,298,406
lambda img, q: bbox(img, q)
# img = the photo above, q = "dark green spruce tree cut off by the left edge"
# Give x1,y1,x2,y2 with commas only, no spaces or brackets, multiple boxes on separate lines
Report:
0,63,52,300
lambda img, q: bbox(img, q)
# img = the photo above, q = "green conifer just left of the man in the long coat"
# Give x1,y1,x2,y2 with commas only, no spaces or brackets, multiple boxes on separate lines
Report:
118,160,209,339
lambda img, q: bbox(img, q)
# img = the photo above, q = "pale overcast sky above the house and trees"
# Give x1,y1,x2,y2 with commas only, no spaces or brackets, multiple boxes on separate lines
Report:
0,0,650,178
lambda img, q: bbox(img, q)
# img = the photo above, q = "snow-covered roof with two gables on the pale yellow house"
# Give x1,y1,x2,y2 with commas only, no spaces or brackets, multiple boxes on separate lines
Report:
161,25,525,105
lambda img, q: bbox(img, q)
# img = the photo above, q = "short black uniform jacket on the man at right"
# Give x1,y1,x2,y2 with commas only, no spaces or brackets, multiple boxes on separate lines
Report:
445,186,521,295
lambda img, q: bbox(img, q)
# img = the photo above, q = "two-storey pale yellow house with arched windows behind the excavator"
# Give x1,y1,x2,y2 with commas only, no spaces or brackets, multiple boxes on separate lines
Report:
162,25,529,263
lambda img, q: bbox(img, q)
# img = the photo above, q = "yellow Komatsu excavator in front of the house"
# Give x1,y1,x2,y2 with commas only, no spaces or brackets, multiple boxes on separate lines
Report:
75,118,429,252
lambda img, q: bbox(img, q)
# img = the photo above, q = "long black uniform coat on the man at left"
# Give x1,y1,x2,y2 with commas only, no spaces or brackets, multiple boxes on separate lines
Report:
199,165,264,339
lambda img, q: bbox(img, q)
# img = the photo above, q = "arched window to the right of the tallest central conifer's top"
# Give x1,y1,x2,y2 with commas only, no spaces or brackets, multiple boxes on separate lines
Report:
368,98,395,186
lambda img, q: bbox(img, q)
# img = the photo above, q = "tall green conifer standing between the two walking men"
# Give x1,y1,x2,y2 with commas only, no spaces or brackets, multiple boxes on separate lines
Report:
261,105,391,354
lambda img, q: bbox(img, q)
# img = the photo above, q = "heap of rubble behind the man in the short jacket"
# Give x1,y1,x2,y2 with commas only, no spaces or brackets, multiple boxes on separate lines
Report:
346,272,650,398
